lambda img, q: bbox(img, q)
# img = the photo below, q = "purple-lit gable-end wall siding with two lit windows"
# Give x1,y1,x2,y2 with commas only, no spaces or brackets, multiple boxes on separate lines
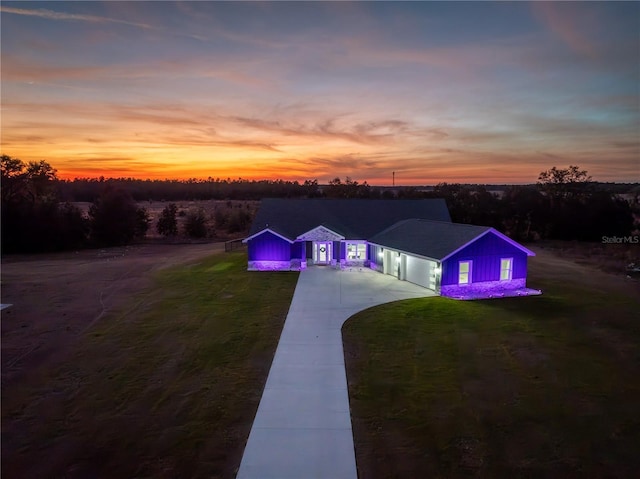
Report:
441,233,527,285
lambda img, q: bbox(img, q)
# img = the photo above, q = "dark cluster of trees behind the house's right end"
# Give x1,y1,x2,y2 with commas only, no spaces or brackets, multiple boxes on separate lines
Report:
426,166,640,242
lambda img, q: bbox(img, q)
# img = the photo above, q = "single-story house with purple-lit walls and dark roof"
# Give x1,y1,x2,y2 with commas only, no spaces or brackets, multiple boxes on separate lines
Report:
243,199,540,299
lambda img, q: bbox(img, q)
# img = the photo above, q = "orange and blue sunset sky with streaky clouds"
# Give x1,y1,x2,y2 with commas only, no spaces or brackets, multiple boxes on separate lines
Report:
0,1,640,185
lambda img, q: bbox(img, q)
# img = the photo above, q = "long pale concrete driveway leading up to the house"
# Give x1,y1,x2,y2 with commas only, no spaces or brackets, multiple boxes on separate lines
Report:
237,266,433,479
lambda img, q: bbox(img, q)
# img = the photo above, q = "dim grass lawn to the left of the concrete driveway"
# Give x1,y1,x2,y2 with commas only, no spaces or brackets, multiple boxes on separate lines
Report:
2,253,297,478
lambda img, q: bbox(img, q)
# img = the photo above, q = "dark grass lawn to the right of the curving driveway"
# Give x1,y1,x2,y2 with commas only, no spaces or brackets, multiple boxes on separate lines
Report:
343,253,640,479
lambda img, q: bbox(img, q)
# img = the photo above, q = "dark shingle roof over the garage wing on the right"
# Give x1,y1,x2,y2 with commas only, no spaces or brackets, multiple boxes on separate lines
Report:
369,219,491,260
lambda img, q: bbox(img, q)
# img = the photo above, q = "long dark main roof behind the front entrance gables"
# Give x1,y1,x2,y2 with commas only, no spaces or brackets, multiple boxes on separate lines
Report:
249,199,451,240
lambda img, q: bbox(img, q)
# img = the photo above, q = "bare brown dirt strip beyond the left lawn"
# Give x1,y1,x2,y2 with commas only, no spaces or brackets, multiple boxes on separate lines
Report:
1,243,224,397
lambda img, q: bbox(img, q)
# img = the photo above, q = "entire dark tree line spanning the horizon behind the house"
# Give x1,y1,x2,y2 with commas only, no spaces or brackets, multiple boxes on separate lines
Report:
1,155,640,253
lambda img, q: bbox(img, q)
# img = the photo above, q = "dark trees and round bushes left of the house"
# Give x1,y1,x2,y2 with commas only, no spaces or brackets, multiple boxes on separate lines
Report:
0,155,253,253
